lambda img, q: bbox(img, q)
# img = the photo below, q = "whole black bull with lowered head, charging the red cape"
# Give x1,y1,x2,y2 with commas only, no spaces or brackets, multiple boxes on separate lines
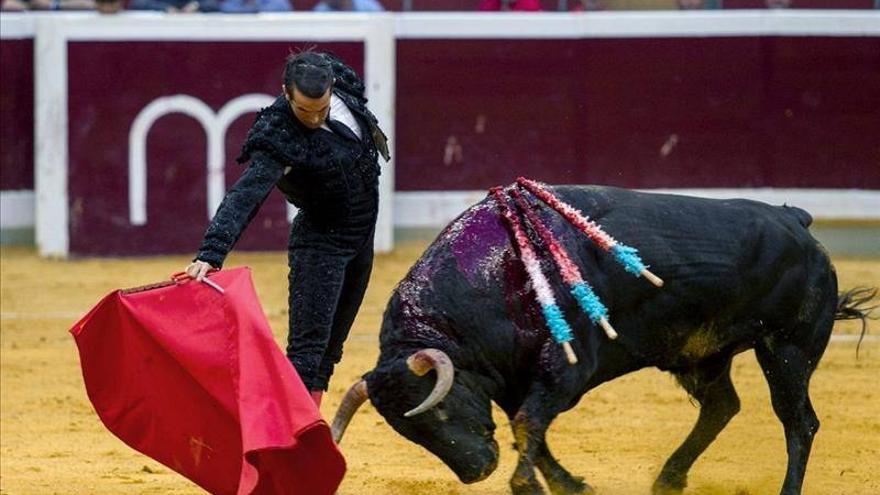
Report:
334,186,871,494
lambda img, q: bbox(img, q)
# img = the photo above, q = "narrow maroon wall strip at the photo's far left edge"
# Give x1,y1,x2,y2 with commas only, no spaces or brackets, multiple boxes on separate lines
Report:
0,40,34,190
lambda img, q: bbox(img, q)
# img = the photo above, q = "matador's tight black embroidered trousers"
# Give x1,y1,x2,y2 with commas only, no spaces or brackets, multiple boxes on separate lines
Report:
287,218,373,390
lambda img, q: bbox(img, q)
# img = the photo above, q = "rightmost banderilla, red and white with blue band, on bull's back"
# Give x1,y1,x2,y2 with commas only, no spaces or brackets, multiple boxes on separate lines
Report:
516,177,663,287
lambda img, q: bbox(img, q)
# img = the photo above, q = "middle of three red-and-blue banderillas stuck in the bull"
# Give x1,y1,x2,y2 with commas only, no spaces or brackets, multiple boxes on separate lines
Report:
510,189,617,340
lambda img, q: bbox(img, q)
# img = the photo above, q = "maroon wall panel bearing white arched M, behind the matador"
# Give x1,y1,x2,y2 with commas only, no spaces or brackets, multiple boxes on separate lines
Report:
68,41,364,255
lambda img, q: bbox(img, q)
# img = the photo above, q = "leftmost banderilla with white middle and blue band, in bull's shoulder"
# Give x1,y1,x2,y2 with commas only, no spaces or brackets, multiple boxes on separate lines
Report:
489,187,577,364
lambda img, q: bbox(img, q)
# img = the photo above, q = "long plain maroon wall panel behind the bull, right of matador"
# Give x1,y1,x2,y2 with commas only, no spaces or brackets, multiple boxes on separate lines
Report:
395,37,880,191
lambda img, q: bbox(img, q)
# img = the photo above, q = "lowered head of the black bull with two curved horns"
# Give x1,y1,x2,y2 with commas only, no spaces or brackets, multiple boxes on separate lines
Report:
333,349,498,483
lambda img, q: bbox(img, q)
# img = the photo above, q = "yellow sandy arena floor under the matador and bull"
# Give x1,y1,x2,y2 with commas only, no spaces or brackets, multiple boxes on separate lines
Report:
0,244,880,495
